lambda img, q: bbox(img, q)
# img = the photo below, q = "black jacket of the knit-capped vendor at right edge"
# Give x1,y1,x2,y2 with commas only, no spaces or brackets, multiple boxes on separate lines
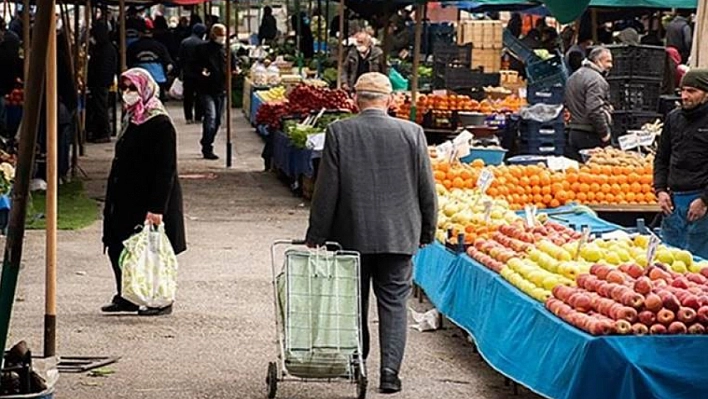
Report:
654,104,708,203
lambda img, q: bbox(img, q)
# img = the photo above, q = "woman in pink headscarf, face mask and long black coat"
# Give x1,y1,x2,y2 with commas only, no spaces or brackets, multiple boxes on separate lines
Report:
101,68,187,316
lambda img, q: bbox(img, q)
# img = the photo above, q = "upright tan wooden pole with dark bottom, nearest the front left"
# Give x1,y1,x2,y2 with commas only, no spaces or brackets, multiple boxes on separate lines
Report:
44,3,58,357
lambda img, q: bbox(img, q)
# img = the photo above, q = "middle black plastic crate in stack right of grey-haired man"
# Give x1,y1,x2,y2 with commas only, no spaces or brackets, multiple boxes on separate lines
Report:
608,79,661,112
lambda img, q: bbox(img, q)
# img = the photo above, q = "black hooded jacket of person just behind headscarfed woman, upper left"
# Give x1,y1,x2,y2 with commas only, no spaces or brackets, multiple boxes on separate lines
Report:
88,21,118,88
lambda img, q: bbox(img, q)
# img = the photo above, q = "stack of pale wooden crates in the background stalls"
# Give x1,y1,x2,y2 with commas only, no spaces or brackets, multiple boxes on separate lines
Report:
457,21,504,73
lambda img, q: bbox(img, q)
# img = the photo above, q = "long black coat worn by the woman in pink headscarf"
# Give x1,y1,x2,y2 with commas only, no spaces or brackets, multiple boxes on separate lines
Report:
103,115,187,254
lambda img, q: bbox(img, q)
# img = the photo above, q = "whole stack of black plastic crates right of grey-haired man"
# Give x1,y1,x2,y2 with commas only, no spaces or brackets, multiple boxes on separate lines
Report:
607,45,666,140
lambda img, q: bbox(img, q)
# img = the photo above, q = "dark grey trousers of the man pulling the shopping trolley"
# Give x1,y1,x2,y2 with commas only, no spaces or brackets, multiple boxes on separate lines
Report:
361,254,413,372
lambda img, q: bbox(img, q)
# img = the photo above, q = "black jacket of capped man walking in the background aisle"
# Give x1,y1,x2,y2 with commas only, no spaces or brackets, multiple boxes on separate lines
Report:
195,41,236,94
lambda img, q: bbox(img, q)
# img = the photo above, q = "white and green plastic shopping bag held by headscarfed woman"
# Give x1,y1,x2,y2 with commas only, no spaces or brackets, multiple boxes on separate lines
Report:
119,224,177,308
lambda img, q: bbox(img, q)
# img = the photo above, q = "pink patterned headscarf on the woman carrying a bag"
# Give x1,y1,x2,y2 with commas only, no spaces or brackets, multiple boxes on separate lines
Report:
120,68,169,125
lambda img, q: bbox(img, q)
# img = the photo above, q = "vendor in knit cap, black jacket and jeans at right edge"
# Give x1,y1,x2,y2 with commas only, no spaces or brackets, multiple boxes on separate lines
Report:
654,69,708,258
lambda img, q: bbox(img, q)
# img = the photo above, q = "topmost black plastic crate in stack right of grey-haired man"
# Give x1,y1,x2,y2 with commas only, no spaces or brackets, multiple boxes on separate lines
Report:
608,45,666,79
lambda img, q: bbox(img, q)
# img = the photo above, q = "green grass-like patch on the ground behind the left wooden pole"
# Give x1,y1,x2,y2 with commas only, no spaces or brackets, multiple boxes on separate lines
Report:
27,180,99,230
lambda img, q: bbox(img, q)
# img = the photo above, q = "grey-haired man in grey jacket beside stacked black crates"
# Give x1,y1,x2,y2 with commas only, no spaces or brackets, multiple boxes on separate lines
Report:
565,46,612,161
